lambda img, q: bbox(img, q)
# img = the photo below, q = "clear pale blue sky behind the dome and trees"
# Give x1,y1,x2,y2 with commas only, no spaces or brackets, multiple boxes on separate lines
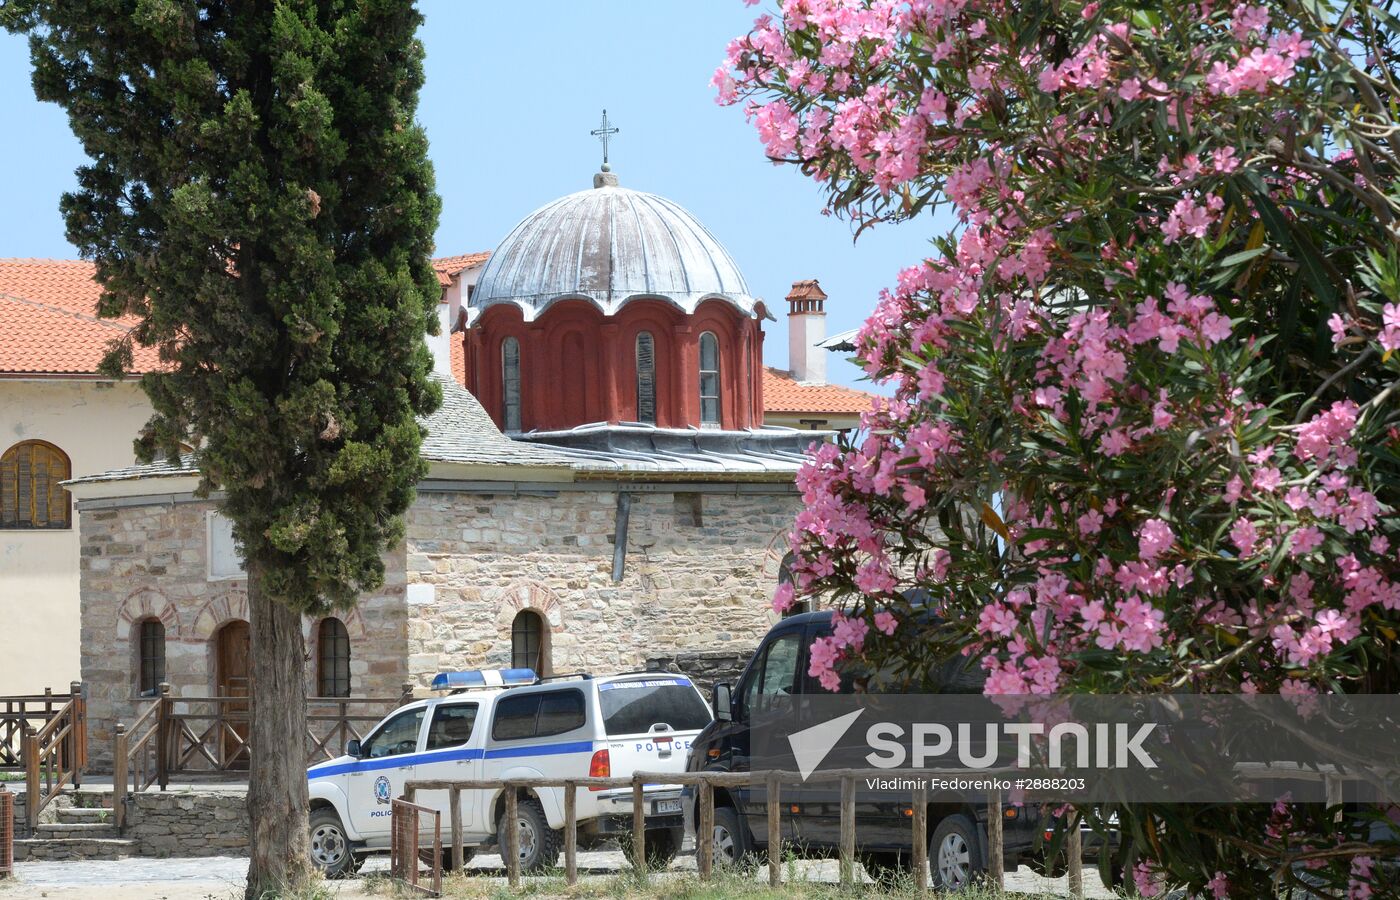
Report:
0,0,939,385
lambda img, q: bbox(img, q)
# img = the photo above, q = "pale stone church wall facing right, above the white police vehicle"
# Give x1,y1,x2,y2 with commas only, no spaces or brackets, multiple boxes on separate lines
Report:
407,490,799,684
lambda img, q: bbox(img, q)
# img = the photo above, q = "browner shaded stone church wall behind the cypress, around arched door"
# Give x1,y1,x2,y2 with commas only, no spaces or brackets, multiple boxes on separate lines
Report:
78,502,407,773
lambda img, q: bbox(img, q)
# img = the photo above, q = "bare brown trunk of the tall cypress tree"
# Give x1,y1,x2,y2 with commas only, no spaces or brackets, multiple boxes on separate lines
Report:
244,571,314,900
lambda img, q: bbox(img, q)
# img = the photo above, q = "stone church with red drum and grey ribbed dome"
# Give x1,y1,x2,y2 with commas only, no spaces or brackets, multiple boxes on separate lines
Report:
16,169,871,766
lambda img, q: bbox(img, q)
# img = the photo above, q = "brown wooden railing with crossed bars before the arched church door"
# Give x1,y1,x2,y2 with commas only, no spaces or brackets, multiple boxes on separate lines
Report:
112,684,413,831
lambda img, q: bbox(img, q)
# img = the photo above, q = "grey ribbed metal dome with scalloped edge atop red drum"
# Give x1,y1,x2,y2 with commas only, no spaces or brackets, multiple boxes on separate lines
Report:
468,172,756,321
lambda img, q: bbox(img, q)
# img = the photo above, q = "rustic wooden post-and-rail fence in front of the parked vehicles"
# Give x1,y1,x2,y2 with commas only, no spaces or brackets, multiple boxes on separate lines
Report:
391,770,1084,897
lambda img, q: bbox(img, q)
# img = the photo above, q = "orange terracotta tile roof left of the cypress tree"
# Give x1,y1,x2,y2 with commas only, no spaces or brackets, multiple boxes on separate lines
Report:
0,259,158,375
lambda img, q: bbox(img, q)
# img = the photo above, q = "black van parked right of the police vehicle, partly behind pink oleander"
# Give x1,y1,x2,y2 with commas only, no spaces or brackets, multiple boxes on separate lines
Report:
683,610,1040,890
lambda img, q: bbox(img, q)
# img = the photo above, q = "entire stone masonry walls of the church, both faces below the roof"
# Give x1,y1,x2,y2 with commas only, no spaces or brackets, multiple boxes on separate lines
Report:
71,483,799,773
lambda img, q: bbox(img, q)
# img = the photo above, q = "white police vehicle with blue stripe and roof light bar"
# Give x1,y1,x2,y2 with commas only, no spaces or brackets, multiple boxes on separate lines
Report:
307,669,711,878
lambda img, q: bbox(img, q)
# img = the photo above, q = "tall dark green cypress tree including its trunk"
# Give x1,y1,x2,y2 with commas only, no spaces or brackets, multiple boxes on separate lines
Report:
0,0,441,897
